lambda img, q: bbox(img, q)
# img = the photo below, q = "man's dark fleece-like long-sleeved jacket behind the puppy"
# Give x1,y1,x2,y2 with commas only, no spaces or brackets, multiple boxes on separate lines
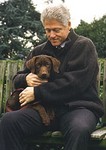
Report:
14,29,103,117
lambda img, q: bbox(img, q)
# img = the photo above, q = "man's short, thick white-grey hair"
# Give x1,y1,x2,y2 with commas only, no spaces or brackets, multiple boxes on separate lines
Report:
41,4,70,26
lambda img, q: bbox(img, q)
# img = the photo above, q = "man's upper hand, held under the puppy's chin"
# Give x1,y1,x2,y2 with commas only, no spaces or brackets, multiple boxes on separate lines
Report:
26,73,47,87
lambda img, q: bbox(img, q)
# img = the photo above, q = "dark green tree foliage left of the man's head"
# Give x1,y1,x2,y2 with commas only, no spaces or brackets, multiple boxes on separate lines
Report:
0,0,45,59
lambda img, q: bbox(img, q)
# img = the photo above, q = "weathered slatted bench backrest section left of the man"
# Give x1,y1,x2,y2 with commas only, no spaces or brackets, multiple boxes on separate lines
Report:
0,60,24,114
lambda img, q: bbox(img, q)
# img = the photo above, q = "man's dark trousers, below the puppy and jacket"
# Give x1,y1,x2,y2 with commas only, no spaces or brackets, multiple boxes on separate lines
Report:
0,107,98,150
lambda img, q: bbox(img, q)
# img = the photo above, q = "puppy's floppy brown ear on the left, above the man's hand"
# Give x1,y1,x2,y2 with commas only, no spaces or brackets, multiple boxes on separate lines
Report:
26,56,36,73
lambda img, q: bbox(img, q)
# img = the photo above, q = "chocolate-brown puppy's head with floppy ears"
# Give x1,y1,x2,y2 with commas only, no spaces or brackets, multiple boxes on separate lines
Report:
26,55,60,79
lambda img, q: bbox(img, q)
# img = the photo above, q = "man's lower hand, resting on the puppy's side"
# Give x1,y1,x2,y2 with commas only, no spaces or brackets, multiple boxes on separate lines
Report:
19,87,35,106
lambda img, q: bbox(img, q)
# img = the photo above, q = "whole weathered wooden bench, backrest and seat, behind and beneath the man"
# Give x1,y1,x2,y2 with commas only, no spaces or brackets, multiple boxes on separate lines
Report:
0,59,106,150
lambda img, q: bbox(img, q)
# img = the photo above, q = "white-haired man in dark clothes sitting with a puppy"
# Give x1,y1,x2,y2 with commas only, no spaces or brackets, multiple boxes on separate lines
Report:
0,5,103,150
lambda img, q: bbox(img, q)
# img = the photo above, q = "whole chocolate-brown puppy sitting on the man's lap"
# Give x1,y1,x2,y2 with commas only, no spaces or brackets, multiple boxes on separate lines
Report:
6,55,60,125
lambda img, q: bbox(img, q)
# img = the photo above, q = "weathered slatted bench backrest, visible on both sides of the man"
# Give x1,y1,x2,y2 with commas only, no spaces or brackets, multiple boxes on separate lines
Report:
0,59,106,122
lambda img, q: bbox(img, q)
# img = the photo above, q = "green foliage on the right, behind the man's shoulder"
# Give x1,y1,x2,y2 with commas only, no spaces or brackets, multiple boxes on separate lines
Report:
75,15,106,58
